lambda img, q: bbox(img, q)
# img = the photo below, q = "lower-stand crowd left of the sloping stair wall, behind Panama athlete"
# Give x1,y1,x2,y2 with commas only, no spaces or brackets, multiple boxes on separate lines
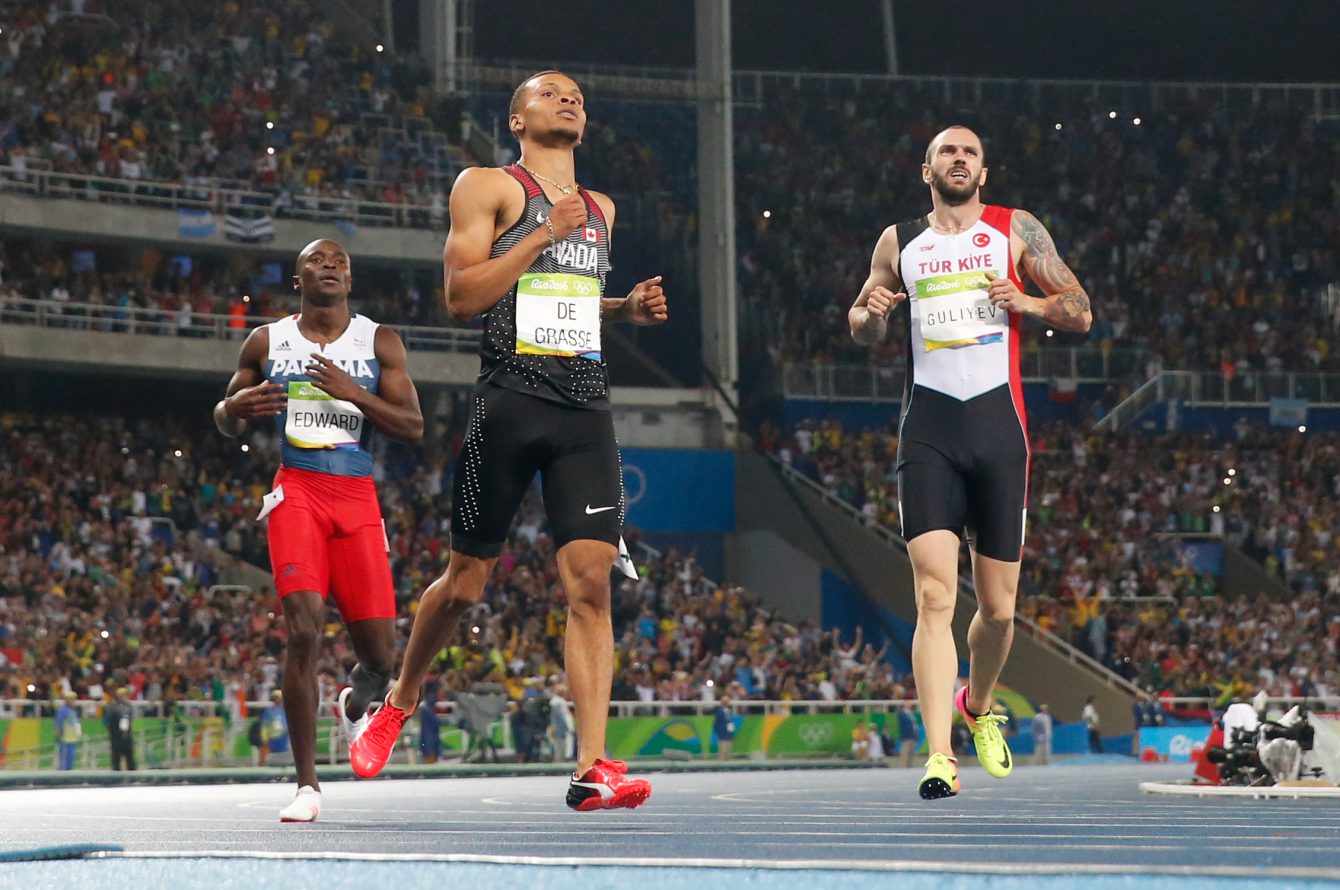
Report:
0,414,902,718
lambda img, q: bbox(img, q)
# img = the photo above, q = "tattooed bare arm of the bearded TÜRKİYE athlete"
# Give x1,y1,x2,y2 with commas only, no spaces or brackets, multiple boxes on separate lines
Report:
988,210,1093,332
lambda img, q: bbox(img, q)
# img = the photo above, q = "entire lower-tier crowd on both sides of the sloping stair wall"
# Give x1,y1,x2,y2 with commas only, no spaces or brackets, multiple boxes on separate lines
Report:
0,414,1340,718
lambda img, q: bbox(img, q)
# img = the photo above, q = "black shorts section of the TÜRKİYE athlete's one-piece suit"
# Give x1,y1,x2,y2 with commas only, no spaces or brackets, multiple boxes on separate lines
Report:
898,385,1029,563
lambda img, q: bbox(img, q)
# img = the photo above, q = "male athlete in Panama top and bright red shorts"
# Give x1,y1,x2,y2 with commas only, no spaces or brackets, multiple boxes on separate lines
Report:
214,240,423,822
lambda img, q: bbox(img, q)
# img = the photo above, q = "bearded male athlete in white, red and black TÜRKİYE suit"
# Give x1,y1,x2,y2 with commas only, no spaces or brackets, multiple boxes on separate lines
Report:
848,126,1093,800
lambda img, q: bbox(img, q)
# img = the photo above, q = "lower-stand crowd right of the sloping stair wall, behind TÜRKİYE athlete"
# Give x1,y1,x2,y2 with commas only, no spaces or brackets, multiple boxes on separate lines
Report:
760,420,1340,694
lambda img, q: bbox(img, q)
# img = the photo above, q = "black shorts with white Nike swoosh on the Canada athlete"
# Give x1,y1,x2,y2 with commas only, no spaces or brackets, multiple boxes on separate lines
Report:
452,383,623,559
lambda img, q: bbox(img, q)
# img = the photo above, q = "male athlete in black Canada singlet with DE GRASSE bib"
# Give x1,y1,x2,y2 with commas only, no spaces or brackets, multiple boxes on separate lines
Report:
351,71,667,811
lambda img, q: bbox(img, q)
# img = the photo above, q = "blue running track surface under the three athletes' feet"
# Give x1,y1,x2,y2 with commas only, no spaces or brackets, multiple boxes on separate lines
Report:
0,759,1340,890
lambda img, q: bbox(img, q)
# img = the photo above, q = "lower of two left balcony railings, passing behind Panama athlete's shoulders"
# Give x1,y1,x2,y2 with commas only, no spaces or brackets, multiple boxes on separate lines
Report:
0,298,480,353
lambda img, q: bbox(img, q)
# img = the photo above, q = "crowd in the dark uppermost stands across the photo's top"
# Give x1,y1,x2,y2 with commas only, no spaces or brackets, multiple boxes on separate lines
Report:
0,12,1340,394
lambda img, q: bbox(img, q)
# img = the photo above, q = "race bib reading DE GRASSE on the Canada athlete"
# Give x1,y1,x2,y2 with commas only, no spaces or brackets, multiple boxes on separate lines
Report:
516,272,600,361
